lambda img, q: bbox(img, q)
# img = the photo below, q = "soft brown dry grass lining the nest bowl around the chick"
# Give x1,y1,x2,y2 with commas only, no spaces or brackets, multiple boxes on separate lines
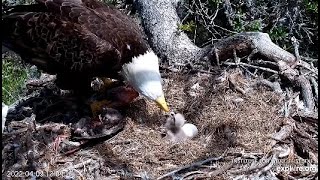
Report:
105,71,282,177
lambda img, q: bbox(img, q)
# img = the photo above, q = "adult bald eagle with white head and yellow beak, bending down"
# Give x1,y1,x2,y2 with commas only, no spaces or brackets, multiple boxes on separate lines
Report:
2,0,169,111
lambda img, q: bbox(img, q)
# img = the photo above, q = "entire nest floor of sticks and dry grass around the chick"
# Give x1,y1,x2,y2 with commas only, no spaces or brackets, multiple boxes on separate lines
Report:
2,70,318,179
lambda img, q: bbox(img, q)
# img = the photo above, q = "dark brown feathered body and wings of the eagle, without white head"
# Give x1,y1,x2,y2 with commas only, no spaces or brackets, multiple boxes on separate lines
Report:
2,0,147,76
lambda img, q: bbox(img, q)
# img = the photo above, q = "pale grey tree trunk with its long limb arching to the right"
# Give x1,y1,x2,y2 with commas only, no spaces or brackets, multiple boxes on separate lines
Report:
135,0,318,114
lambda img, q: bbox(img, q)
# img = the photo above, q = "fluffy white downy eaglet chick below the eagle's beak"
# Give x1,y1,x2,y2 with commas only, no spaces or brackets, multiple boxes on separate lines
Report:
165,113,198,142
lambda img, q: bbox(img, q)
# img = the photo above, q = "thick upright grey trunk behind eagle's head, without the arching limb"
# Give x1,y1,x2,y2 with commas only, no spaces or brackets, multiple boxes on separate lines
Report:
136,0,202,65
